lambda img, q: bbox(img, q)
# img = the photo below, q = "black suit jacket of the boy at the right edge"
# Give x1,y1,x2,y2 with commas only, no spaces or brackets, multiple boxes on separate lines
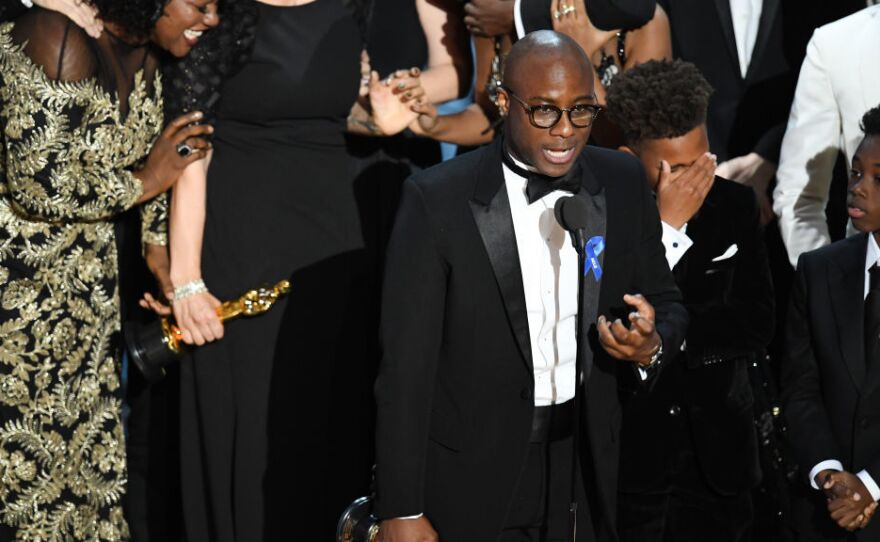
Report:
782,234,880,540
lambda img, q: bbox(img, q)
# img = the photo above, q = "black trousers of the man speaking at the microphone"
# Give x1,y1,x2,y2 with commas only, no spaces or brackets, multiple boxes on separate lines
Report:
497,437,595,542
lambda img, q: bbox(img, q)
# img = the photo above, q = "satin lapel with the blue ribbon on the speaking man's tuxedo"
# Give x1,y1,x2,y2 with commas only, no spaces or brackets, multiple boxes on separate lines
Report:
575,157,607,382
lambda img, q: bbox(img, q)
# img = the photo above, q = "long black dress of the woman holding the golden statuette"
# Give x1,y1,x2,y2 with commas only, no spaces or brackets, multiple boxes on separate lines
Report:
181,0,378,542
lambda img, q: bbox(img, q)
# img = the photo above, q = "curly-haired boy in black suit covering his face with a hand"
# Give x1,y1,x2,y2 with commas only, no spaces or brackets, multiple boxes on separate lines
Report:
608,60,774,542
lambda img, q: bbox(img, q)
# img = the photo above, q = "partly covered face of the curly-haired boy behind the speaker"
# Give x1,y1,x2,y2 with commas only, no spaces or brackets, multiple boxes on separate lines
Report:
632,125,709,189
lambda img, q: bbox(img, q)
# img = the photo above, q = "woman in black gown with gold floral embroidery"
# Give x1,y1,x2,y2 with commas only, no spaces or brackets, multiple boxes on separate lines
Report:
0,0,218,541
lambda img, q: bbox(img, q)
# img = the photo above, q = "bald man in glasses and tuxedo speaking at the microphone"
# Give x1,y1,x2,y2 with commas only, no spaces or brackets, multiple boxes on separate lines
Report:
374,31,687,542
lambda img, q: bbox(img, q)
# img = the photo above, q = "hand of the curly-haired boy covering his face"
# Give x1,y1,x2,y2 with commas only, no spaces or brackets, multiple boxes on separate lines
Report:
657,152,717,230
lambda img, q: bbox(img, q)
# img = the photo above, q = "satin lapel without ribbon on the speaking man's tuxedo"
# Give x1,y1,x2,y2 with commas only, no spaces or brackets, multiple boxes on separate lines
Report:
469,138,534,376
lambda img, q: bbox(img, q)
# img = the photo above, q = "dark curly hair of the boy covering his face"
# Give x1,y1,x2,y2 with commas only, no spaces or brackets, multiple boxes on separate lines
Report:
606,60,713,146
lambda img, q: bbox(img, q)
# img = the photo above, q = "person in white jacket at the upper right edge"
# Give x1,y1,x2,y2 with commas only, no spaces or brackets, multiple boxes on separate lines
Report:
773,5,880,265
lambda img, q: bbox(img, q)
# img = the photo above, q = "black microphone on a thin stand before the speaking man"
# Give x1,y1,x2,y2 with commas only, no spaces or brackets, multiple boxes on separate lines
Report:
568,228,587,542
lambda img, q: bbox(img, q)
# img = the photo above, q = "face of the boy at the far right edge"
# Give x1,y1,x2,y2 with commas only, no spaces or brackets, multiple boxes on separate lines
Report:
846,136,880,237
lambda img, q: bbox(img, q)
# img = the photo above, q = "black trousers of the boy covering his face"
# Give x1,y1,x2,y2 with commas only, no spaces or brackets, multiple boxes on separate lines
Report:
617,448,753,542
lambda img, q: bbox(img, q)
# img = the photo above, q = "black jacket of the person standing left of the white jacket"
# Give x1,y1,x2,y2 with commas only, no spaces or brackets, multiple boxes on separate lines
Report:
660,0,806,163
